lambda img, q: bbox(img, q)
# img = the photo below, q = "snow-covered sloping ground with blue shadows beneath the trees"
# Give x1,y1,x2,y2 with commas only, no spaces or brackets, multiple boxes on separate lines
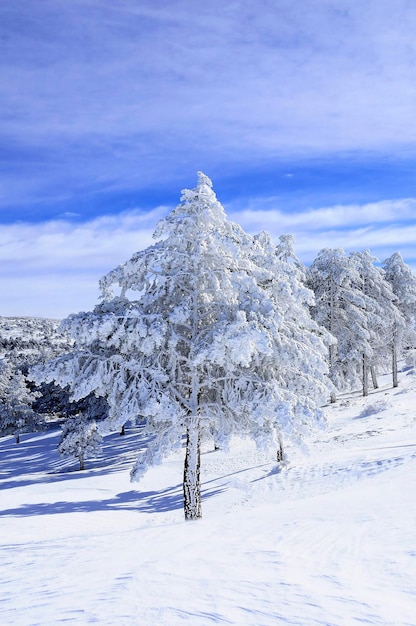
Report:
0,372,416,626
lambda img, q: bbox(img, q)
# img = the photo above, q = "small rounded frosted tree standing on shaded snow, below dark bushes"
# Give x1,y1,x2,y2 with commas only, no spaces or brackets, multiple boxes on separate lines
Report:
58,414,103,470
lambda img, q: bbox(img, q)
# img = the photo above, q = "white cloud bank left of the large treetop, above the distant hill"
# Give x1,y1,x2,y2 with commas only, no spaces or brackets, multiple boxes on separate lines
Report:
0,207,166,319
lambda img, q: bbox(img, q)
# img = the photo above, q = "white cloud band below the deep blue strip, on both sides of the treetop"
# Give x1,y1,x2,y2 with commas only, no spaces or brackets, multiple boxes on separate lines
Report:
0,198,416,318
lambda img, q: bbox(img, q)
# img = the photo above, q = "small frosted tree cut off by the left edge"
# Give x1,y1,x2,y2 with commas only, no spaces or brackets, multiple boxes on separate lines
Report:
0,359,39,443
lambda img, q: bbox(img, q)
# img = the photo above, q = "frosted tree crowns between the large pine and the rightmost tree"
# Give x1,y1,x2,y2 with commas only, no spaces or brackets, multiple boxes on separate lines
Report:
308,248,404,394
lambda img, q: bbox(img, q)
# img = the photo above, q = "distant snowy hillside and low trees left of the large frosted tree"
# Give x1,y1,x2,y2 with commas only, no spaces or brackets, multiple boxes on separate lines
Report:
0,317,108,468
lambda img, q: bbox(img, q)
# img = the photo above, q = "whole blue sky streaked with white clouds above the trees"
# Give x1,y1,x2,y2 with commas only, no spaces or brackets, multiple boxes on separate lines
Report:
0,0,416,318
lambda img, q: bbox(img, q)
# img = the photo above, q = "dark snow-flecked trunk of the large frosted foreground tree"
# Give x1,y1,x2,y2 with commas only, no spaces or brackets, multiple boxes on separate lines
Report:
183,422,202,520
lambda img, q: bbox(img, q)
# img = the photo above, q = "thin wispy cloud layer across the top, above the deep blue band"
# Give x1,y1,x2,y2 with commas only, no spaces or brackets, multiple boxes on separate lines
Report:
0,0,416,212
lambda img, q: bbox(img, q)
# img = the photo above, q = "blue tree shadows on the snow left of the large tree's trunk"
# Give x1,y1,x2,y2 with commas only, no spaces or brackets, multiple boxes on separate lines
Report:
0,427,228,517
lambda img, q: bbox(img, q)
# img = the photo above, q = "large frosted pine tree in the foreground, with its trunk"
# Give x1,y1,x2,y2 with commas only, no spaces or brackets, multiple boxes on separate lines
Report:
31,173,328,519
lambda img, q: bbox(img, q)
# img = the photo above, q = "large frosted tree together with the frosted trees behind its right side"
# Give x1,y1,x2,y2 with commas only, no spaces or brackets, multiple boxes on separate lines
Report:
23,173,416,519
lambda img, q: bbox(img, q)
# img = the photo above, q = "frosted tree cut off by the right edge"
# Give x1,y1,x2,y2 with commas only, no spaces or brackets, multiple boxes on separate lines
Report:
383,252,416,370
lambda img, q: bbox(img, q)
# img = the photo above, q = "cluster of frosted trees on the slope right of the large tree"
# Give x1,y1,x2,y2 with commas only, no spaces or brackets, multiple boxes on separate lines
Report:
307,249,416,401
